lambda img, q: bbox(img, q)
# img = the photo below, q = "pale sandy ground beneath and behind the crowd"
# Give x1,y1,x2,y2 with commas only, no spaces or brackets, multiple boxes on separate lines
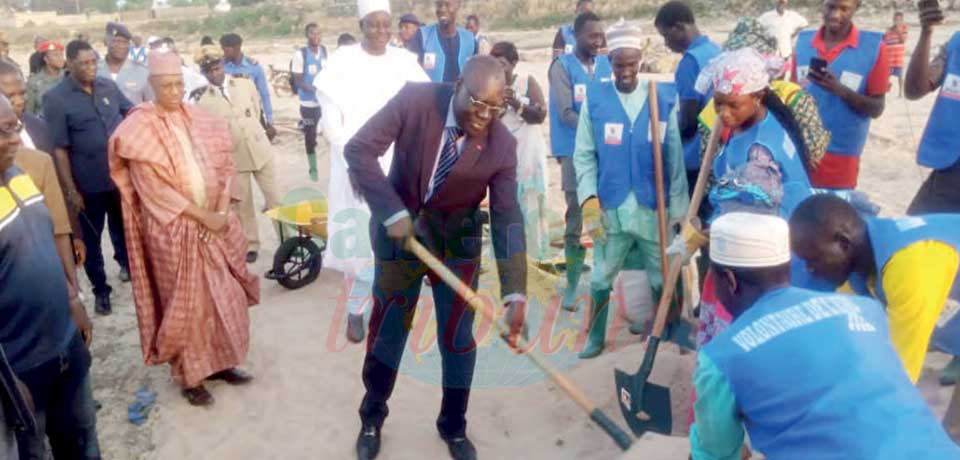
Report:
45,12,949,460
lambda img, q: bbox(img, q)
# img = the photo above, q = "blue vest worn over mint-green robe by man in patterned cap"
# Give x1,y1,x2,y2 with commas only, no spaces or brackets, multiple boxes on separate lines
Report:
587,81,677,209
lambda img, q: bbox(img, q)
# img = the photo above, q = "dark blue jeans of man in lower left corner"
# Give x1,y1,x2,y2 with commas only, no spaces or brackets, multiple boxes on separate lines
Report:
17,333,100,460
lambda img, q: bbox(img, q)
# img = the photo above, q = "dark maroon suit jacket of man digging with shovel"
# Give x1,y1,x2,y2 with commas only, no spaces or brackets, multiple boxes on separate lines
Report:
344,83,527,296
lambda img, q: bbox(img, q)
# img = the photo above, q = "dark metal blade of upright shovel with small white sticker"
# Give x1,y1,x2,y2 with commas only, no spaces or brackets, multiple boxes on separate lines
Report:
614,369,673,438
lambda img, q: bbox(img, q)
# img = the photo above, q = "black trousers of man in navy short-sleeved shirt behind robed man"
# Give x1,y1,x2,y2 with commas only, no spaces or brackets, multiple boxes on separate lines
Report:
80,190,127,296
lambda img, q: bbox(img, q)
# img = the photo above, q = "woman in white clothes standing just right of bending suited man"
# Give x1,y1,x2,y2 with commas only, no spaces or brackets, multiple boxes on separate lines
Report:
490,42,552,263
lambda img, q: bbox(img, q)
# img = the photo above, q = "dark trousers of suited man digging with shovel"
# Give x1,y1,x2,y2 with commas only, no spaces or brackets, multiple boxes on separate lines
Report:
360,246,480,439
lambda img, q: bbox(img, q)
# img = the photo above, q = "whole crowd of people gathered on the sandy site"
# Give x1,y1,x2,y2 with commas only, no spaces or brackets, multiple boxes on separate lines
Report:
0,0,960,460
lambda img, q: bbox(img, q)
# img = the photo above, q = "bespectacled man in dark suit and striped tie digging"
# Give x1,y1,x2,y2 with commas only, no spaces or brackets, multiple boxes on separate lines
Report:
344,56,527,459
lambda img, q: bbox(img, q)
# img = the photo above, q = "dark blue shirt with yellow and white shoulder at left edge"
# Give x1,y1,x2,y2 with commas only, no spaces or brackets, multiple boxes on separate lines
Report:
0,166,77,372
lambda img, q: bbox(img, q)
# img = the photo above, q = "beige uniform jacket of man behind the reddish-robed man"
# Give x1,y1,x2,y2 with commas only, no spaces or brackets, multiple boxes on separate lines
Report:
190,77,271,172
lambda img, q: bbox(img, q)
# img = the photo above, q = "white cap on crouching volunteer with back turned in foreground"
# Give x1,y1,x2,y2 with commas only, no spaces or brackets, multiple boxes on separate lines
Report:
710,212,790,268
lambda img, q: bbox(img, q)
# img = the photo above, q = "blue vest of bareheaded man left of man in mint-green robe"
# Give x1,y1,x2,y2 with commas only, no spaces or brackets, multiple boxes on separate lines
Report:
550,54,613,157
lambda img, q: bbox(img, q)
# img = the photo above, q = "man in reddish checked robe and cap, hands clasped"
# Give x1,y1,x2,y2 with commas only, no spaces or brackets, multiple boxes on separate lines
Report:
109,51,260,406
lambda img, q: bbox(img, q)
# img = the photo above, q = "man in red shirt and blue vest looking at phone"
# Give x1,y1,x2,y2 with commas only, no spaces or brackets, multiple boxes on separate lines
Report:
793,0,890,191
